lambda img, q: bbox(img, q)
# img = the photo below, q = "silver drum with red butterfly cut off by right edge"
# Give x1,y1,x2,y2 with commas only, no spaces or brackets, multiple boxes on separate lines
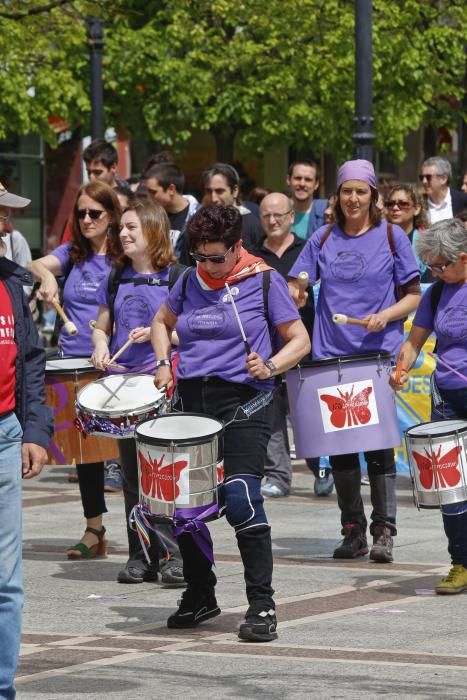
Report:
405,420,467,508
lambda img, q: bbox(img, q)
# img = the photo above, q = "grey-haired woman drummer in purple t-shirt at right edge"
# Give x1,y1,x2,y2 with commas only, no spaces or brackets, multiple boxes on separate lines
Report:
391,219,467,593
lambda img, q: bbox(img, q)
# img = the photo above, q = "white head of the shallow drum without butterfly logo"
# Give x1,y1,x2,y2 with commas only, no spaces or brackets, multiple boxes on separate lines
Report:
77,374,164,416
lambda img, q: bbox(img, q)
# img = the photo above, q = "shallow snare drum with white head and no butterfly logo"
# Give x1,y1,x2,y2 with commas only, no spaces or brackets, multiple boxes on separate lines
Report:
76,374,165,439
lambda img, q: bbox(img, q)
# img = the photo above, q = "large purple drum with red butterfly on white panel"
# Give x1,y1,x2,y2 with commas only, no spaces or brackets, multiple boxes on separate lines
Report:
286,352,401,457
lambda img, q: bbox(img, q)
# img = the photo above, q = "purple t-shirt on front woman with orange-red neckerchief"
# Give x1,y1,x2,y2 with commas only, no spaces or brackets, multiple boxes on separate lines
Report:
167,270,300,391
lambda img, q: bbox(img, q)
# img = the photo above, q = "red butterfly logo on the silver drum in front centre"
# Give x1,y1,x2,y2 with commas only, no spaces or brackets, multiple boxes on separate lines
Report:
138,450,188,503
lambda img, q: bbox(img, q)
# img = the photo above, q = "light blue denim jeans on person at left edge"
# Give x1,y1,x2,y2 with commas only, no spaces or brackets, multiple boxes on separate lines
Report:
0,413,23,700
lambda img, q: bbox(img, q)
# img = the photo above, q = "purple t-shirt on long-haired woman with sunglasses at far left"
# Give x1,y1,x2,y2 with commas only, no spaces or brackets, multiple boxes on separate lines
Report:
51,243,111,357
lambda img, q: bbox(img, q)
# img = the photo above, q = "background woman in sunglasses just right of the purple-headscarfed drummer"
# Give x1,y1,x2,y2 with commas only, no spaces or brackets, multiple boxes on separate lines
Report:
384,183,433,282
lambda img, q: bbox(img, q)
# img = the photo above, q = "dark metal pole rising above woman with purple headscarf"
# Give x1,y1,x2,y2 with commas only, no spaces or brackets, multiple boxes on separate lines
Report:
352,0,375,161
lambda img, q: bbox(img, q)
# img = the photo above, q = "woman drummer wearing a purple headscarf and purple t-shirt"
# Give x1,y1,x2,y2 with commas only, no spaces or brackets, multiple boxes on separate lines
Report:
289,160,420,562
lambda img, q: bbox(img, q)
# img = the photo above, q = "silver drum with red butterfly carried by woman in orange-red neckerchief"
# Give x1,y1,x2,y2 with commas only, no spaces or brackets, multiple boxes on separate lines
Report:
135,413,224,519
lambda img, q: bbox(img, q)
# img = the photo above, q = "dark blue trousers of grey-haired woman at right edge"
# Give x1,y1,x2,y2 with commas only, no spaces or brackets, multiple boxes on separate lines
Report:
431,377,467,569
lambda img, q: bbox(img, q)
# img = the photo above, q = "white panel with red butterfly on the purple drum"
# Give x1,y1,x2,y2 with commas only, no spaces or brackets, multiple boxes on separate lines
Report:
318,379,379,433
